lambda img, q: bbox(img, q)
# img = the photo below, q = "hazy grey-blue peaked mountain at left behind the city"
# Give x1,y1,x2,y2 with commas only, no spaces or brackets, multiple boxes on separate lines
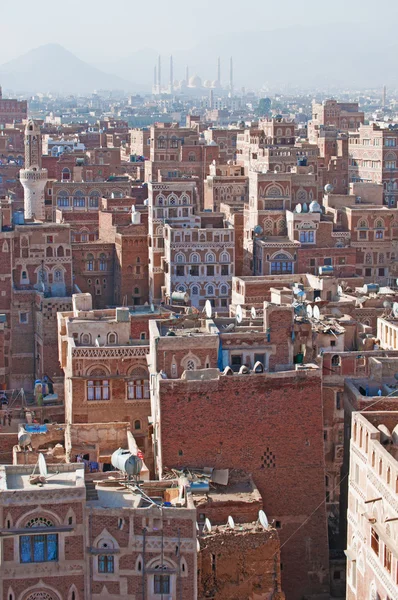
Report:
0,44,135,94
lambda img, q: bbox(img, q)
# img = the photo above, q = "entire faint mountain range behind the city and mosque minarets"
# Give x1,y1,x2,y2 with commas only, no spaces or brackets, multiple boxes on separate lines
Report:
0,23,398,94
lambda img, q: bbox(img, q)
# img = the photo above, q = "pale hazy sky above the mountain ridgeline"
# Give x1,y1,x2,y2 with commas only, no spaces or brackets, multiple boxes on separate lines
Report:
0,0,398,64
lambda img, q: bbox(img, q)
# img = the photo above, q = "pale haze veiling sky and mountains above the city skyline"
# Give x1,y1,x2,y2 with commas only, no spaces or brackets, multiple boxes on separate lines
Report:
0,0,398,92
